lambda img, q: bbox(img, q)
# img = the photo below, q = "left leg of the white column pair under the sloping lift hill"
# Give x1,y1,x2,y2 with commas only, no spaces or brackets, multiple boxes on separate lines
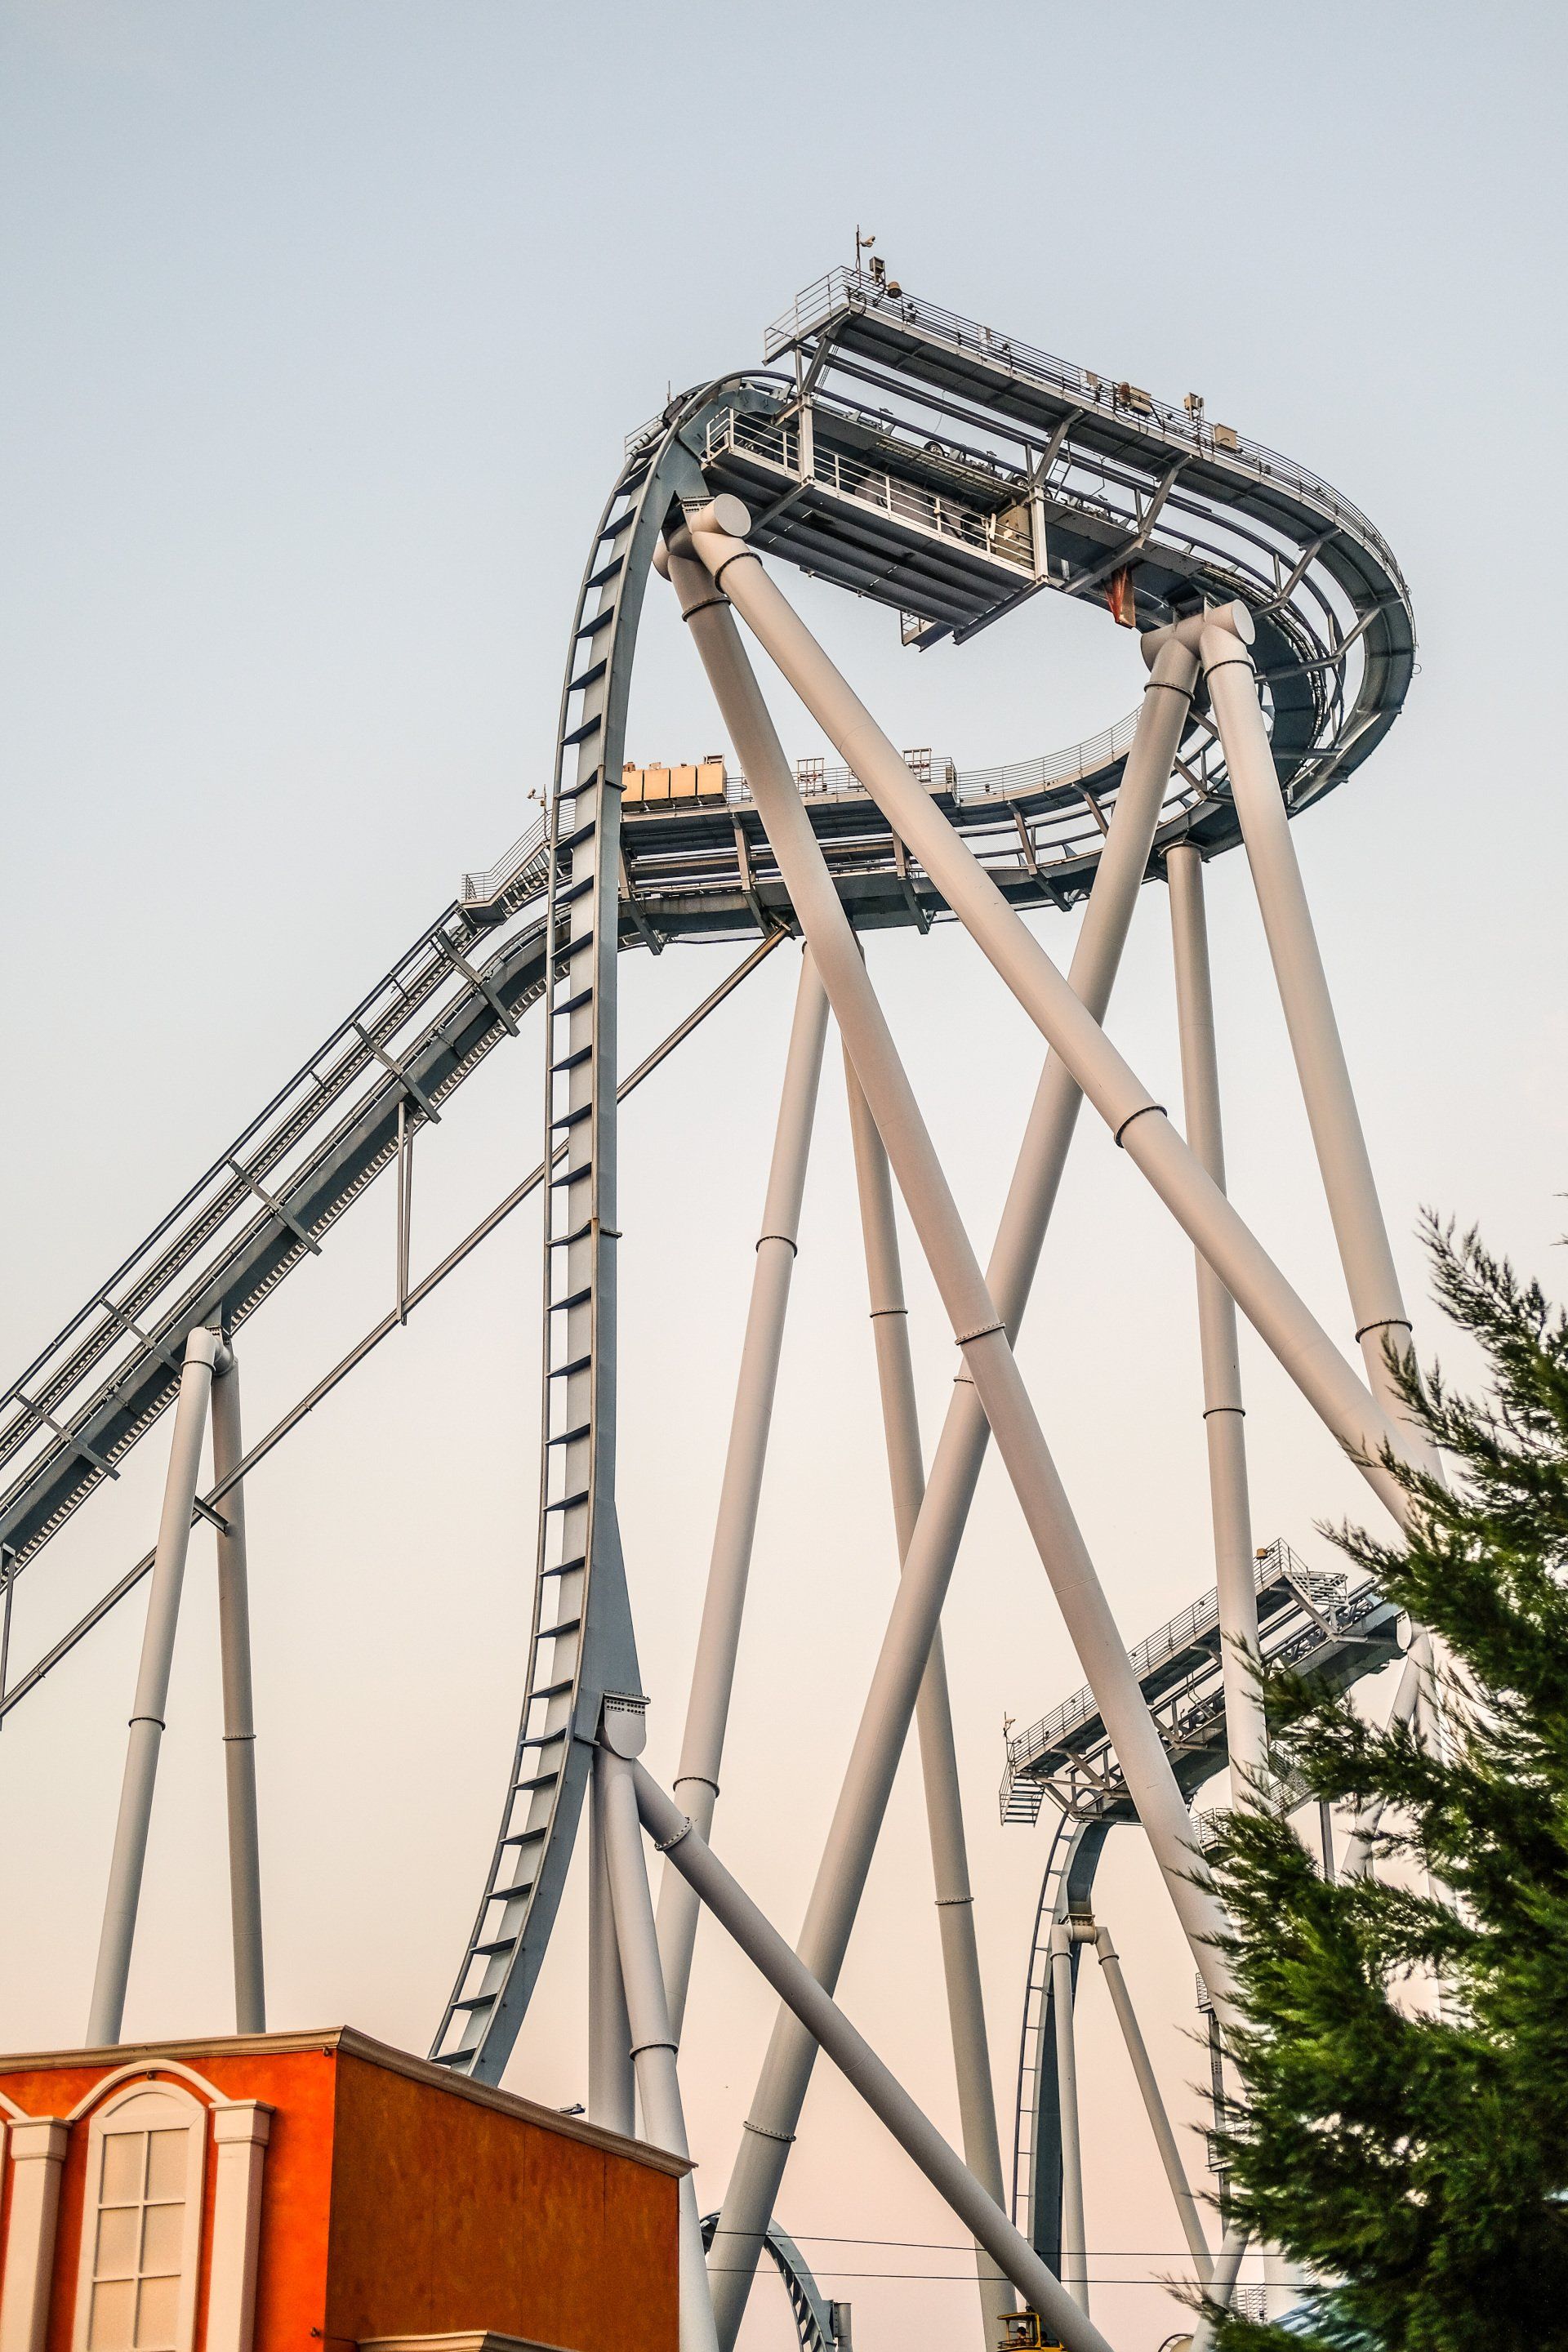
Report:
87,1326,223,2047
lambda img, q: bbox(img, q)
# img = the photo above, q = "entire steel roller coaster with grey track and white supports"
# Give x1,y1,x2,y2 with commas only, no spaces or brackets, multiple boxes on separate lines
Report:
0,256,1423,2352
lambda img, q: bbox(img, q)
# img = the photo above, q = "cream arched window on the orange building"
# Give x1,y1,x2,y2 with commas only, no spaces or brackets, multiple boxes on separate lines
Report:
73,2082,207,2352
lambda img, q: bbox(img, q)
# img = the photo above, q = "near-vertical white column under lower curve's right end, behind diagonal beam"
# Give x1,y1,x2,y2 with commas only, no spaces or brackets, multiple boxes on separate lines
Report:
1166,842,1267,1804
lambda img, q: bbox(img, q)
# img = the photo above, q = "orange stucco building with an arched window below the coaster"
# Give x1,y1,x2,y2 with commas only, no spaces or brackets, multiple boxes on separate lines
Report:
0,2028,687,2352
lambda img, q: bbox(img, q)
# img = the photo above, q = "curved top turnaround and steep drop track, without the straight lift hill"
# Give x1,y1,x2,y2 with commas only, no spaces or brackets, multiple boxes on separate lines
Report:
433,273,1415,2082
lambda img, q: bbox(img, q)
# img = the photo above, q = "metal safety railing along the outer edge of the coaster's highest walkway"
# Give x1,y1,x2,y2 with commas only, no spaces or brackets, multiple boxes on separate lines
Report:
762,268,1408,595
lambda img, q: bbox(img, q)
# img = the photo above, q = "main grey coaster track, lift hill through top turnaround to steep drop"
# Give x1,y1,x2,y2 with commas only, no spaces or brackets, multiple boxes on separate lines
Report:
0,273,1415,2136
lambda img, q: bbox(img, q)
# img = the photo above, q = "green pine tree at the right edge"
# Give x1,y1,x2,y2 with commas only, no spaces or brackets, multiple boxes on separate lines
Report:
1213,1221,1568,2352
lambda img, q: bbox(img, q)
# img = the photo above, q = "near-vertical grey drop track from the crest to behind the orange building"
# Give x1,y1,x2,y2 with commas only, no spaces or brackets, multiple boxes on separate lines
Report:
430,435,703,2082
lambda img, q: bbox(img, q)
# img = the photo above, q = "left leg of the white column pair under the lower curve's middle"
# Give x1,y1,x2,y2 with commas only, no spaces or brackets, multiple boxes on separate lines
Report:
658,948,827,2039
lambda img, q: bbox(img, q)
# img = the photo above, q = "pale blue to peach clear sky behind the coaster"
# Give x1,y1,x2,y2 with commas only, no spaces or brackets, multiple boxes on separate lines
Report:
0,13,1568,2352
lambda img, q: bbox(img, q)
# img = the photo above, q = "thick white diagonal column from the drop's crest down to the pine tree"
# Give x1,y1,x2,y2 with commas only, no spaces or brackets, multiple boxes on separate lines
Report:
688,499,1410,1533
